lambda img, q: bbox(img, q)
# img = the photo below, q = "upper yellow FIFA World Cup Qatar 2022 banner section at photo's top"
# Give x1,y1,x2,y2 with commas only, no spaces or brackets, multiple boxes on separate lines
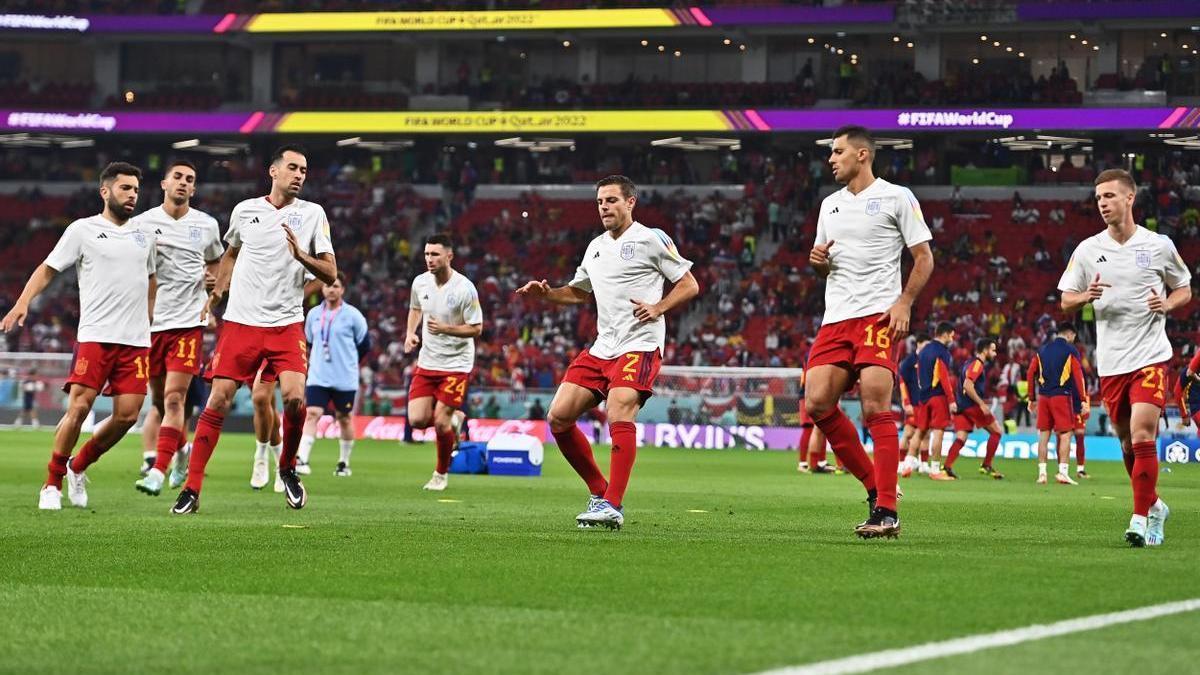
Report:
245,8,679,32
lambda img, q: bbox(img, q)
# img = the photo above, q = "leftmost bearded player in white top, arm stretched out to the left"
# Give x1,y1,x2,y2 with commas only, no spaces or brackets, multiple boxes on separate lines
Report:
0,162,156,510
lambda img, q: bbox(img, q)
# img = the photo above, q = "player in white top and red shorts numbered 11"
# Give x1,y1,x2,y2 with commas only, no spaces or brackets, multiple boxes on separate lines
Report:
130,160,224,495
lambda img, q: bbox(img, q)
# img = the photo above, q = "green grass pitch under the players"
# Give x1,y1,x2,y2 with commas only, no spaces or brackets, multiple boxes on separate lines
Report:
0,431,1200,675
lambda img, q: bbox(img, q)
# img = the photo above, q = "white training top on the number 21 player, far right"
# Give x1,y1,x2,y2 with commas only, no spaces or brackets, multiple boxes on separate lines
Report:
1058,226,1192,377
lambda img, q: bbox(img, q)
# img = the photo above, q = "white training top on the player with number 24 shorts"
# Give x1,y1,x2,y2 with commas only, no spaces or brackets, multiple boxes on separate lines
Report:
408,269,484,372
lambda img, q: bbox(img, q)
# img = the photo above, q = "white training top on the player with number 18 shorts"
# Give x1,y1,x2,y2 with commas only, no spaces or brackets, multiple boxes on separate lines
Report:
815,178,934,323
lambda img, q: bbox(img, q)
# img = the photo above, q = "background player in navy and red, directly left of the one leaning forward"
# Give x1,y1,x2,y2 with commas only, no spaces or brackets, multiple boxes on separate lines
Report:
917,321,959,480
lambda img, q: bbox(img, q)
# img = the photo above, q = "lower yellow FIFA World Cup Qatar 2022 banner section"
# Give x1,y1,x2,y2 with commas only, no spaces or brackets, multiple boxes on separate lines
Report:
275,110,733,133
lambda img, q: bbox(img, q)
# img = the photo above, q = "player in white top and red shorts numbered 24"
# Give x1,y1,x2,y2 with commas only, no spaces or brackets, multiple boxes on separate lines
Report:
404,234,484,492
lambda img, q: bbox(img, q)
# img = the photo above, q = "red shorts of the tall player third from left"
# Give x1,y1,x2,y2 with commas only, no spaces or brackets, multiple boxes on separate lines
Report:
204,321,308,386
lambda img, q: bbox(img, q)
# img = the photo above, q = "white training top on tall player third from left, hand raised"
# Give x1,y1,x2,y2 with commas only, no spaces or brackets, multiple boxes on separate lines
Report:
224,197,334,327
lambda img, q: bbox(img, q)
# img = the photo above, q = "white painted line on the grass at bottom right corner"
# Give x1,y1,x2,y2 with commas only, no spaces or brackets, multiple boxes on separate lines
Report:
760,598,1200,675
